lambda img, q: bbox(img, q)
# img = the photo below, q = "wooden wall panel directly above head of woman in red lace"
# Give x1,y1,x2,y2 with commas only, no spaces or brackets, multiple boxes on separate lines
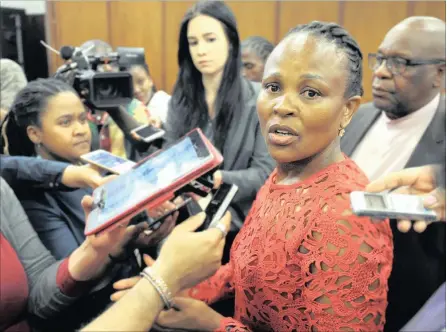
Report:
278,1,340,41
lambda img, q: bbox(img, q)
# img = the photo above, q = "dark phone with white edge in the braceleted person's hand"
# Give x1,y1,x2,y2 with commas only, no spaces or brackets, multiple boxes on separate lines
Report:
197,183,239,231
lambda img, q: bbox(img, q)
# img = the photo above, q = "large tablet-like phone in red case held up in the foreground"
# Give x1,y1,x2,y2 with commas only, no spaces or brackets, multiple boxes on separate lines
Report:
85,129,223,235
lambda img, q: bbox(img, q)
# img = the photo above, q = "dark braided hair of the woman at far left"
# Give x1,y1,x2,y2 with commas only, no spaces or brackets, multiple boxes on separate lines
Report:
1,78,76,156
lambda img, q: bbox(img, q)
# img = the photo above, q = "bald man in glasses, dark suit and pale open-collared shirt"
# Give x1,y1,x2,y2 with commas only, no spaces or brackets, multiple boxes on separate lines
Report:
341,17,446,332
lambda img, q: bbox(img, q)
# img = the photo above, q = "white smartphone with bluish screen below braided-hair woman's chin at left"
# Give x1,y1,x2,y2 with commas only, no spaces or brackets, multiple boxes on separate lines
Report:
81,150,136,174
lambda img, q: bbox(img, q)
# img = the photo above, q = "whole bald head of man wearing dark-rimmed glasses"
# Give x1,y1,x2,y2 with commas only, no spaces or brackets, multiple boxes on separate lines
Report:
373,16,445,118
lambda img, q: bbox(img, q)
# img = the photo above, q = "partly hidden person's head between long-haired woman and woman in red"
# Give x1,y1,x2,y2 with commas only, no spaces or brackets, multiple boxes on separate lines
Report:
241,36,275,82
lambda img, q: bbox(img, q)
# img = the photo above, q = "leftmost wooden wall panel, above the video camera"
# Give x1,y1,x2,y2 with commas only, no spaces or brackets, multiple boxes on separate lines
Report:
50,1,110,73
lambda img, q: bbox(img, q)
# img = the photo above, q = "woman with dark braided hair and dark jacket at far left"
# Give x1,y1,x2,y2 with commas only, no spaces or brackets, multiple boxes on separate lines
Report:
4,78,175,328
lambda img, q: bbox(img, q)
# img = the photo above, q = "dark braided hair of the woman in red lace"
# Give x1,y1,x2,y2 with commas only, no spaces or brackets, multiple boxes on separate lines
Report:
287,21,363,98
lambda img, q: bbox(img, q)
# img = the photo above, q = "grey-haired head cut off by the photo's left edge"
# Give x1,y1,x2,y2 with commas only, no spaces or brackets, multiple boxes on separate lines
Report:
0,59,28,123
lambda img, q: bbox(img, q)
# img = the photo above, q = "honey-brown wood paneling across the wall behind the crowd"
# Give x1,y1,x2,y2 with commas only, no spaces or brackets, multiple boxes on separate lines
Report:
47,0,445,94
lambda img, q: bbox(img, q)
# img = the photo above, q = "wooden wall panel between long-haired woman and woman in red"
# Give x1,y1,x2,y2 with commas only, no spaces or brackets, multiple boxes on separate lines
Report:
227,1,277,43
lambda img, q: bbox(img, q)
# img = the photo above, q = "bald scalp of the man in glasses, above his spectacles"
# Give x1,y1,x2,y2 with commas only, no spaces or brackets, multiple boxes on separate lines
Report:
385,16,445,59
